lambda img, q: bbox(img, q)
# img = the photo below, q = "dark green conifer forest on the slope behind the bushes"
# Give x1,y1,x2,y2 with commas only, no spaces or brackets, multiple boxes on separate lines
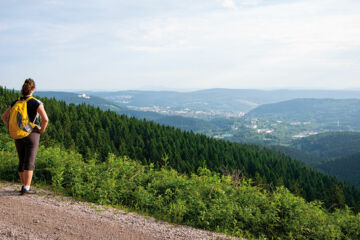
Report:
0,88,360,212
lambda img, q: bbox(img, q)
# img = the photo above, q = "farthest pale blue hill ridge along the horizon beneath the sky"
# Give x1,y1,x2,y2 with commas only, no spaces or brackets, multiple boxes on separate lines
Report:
87,88,360,115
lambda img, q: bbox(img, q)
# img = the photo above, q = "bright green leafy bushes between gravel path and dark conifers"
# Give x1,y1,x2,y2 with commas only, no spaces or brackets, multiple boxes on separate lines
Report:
0,133,360,240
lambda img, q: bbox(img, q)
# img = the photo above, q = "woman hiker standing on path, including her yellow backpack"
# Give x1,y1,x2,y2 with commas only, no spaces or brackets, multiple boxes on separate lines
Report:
1,78,49,194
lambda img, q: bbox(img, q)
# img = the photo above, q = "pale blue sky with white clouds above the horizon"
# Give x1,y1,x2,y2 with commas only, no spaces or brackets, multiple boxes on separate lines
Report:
0,0,360,91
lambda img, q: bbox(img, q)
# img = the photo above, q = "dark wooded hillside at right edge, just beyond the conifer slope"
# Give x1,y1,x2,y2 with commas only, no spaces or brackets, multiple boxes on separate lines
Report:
272,132,360,187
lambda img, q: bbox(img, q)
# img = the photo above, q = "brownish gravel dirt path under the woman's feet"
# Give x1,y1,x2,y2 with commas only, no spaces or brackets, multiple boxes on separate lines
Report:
0,183,242,240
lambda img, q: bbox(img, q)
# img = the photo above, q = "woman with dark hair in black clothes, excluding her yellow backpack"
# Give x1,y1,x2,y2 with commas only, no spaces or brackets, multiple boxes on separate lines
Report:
1,78,49,194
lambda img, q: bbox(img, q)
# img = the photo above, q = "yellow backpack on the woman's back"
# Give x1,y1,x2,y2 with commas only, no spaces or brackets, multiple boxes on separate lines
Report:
9,97,35,139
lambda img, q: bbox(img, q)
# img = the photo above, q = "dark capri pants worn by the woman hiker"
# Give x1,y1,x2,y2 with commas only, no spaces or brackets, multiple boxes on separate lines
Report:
15,127,40,172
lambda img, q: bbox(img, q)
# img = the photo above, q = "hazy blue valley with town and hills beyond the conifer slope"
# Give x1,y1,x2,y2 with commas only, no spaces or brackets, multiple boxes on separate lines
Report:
32,89,360,190
